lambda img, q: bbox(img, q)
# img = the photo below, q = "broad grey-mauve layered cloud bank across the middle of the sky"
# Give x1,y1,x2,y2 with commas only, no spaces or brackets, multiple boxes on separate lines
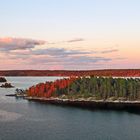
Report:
5,48,116,66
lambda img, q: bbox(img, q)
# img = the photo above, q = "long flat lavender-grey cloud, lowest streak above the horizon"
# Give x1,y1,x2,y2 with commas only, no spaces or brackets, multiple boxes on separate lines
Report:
29,56,112,67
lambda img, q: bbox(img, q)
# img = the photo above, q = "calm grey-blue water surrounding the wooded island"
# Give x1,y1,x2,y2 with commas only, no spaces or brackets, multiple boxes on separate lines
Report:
0,77,140,140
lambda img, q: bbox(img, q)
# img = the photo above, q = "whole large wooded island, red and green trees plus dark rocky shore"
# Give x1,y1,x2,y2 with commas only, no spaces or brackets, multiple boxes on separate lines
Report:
21,76,140,110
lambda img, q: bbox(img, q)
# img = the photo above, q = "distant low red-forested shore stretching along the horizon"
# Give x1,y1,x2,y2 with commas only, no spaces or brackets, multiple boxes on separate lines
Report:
0,69,140,77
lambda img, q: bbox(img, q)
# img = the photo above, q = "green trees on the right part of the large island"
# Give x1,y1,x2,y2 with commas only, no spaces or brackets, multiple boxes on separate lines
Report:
67,77,140,100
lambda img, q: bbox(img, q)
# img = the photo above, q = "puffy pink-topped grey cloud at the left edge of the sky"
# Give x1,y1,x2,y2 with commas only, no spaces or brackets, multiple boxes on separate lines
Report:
0,38,45,52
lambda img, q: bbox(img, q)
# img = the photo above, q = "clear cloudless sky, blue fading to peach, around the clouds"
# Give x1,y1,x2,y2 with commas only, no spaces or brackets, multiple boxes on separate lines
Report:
0,0,140,69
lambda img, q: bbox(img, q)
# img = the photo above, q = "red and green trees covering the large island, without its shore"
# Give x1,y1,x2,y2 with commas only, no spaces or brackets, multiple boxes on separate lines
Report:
28,76,140,100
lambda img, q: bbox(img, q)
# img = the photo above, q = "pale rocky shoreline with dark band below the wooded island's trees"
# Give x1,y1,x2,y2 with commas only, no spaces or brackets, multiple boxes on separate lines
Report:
24,97,140,111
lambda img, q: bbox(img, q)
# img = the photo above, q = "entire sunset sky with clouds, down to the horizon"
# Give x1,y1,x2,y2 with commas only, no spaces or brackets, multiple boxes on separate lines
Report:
0,0,140,70
